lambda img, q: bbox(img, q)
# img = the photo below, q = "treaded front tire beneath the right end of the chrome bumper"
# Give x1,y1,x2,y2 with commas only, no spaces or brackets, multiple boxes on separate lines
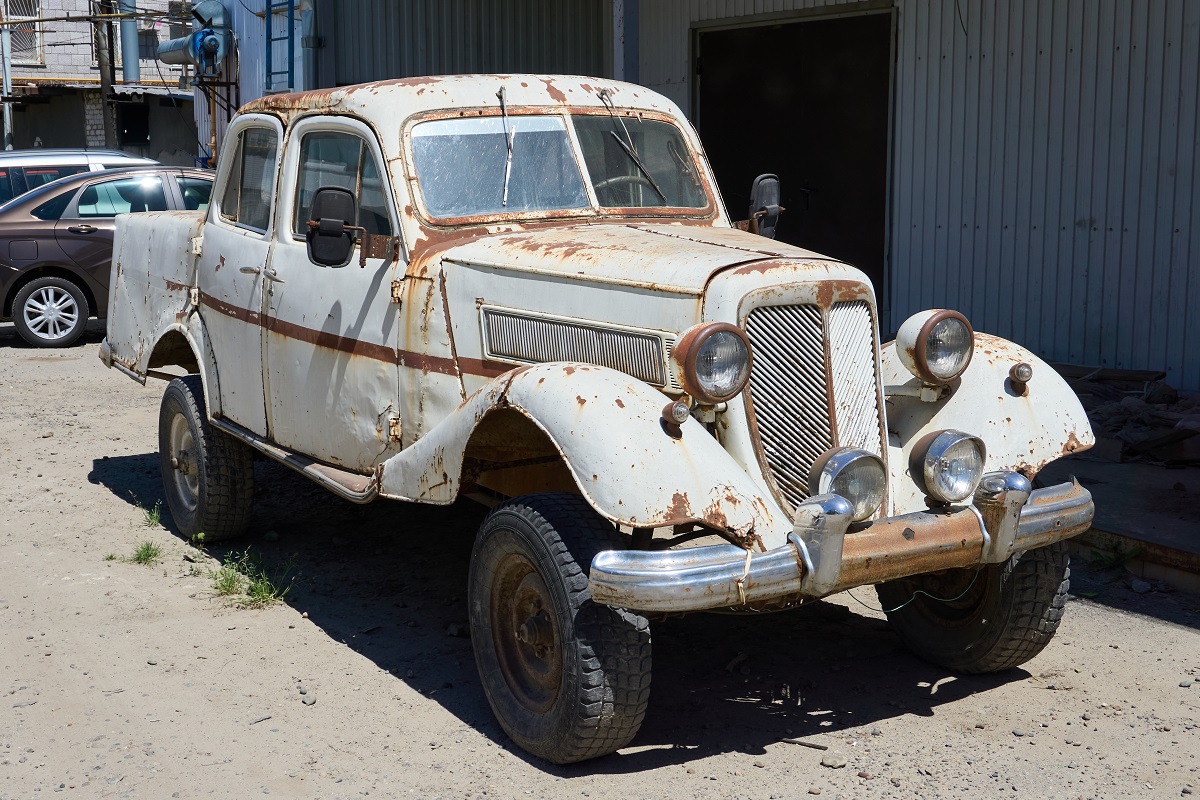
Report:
876,542,1070,673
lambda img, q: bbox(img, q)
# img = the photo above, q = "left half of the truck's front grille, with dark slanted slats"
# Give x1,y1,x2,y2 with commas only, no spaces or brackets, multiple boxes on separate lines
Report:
746,306,833,509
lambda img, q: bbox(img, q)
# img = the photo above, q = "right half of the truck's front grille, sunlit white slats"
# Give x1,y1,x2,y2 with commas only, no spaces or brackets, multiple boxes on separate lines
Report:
829,300,883,456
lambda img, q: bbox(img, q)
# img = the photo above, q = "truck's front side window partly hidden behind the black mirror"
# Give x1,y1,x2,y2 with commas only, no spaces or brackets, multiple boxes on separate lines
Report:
292,132,392,236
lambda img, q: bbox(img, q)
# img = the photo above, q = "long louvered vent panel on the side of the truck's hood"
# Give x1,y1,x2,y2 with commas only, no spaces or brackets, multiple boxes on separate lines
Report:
484,308,667,386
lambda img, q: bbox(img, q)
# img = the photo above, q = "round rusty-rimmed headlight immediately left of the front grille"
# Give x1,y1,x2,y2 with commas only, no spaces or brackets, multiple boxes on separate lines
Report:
672,323,750,405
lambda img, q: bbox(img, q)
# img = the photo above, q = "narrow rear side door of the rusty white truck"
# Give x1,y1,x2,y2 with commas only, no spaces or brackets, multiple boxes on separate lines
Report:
197,114,283,435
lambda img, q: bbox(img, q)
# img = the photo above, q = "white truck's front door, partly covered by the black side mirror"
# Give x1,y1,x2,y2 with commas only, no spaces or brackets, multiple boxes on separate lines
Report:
265,116,403,473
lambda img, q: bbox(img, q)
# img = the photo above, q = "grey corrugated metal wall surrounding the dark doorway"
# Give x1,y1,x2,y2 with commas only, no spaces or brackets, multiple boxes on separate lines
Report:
640,0,1200,390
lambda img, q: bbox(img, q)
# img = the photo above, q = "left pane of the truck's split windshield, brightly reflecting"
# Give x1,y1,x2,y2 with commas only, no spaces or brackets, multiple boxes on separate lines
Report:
413,116,589,218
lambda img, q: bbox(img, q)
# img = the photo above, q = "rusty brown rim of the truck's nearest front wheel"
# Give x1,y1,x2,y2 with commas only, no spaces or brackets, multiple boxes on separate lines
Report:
490,555,563,714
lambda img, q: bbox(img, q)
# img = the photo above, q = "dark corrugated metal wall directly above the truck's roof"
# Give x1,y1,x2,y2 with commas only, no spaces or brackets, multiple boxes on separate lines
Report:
320,0,612,85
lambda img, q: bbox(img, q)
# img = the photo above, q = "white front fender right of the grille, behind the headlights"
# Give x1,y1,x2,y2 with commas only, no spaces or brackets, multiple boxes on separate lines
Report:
882,333,1096,513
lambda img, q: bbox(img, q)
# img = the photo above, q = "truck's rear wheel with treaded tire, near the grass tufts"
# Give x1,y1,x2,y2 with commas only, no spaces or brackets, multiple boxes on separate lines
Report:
158,375,254,542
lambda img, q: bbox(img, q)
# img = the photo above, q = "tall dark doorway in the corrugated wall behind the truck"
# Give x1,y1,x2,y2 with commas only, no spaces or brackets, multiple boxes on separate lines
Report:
696,12,892,302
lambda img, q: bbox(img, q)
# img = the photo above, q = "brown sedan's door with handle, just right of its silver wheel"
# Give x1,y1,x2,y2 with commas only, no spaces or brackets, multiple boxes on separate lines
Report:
54,174,169,278
